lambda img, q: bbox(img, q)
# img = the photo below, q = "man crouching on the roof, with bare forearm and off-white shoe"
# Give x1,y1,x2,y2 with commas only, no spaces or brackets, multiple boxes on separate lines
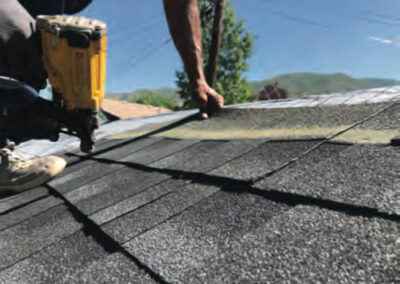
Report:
0,0,223,192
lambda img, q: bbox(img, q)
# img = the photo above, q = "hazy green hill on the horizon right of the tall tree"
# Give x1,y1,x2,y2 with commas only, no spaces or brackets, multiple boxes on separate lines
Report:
250,73,400,97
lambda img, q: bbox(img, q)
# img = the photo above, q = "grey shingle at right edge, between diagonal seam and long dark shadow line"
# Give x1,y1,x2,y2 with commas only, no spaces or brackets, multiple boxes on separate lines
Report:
257,146,400,214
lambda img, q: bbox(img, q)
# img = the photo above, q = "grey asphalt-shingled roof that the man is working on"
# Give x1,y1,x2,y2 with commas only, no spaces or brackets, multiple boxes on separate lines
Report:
0,88,400,283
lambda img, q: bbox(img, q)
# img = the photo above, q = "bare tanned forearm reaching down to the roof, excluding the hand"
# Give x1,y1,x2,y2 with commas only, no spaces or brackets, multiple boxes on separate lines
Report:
164,0,205,84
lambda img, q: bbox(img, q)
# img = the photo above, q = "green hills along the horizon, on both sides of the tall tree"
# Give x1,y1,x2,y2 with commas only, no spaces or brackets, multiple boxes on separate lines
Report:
107,73,400,110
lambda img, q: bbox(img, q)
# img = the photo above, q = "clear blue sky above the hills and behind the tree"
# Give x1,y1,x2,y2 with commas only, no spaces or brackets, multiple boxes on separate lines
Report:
82,0,400,92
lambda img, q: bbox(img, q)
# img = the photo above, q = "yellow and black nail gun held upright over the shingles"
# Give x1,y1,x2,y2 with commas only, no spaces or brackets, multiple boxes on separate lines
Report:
37,15,107,152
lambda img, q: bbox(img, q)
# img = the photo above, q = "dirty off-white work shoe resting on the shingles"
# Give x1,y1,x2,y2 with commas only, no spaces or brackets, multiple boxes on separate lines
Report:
0,148,67,193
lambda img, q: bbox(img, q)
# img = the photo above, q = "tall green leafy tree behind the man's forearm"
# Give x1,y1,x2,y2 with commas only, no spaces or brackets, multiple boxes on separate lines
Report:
176,0,253,108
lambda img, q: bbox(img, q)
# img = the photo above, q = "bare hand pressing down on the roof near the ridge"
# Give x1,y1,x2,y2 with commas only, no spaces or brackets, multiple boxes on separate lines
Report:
194,81,224,119
